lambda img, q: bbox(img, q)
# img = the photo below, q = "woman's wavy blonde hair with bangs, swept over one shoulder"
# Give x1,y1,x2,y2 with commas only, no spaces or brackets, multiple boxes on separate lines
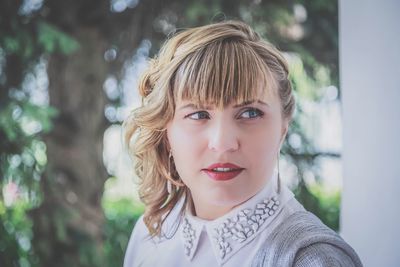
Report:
123,21,295,236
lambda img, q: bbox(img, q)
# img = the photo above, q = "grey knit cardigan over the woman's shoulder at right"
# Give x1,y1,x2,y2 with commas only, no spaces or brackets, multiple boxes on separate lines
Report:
252,211,363,267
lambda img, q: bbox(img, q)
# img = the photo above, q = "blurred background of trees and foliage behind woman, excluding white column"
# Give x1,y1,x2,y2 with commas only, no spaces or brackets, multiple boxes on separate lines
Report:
0,0,342,267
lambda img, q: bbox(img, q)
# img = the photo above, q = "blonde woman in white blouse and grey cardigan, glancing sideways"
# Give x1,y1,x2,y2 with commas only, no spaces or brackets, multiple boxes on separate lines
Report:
124,21,362,267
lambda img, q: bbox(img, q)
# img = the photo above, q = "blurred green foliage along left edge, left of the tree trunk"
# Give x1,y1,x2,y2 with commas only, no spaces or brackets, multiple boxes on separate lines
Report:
0,4,78,267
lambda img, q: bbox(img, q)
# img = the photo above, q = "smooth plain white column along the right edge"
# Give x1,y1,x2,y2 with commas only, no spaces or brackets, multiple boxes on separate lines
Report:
339,0,400,267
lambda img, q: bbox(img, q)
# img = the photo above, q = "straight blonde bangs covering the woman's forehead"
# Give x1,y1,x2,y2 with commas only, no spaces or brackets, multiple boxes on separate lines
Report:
172,38,276,109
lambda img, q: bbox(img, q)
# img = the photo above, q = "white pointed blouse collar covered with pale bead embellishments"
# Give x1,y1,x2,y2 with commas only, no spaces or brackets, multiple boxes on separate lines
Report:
180,173,293,264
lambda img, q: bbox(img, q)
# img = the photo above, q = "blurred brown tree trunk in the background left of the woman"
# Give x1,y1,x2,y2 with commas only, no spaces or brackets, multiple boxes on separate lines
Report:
32,27,108,266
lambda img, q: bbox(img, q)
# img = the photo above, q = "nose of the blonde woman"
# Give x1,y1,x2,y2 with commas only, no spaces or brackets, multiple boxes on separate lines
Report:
208,121,240,154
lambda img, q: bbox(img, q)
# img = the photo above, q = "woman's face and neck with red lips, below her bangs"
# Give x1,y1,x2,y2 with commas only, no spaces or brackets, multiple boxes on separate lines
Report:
167,91,287,219
